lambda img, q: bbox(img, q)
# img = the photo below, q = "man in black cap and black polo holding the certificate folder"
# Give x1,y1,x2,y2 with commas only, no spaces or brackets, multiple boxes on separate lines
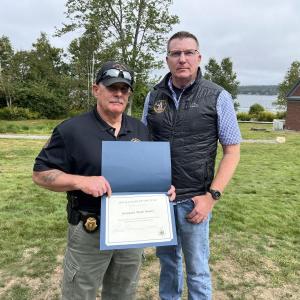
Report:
33,61,175,300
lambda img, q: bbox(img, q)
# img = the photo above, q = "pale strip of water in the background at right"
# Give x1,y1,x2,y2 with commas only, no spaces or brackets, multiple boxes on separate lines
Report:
237,94,280,112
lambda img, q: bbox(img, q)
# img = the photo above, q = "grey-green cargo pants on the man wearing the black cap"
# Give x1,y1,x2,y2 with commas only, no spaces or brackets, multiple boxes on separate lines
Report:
62,222,143,300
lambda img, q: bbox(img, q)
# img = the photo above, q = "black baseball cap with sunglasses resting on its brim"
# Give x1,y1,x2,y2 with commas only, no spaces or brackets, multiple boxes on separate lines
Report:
95,61,134,89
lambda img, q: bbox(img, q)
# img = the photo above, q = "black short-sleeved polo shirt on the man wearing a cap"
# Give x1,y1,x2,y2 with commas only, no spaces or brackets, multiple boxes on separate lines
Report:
33,108,150,213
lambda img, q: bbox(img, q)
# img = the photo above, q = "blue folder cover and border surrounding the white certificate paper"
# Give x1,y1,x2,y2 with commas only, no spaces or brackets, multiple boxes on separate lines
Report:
100,141,177,250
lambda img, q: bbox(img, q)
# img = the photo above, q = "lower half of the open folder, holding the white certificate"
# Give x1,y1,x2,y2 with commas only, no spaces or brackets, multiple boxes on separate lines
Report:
100,193,177,250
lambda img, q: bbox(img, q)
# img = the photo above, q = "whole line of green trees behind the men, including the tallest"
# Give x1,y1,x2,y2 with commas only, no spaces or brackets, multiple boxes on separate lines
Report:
0,0,299,118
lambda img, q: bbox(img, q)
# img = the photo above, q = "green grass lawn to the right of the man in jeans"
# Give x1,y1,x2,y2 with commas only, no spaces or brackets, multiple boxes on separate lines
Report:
211,131,300,299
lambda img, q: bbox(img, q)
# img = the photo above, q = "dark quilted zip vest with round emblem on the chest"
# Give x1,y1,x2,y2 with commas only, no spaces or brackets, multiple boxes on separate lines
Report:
147,69,222,201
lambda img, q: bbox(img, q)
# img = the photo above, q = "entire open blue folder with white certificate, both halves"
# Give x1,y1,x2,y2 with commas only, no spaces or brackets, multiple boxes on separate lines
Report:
100,141,177,250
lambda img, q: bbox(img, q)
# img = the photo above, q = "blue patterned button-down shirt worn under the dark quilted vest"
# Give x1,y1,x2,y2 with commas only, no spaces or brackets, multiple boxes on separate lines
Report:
142,80,242,145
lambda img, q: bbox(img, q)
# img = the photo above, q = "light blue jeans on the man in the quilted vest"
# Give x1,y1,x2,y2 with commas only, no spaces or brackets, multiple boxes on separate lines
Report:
156,199,212,300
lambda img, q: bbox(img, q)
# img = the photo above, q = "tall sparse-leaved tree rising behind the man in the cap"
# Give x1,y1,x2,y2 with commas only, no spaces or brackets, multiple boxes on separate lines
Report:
57,0,178,114
